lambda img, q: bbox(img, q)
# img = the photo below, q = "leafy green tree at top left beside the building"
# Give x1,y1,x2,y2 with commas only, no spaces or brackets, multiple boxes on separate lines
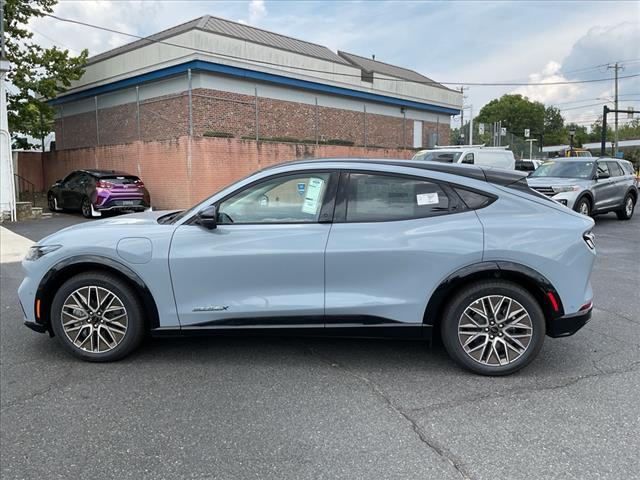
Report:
4,0,89,148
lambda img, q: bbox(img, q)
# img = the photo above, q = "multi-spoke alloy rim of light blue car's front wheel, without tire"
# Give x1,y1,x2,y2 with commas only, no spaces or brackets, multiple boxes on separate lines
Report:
61,285,129,353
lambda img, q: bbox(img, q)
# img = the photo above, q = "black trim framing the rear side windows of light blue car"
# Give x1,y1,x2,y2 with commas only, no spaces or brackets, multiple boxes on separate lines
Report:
333,170,468,223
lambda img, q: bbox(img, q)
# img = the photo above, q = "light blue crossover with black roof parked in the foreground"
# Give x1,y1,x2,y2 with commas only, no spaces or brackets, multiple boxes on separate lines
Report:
18,159,595,375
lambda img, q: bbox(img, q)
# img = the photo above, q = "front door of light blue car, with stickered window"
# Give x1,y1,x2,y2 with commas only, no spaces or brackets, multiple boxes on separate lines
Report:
169,171,337,328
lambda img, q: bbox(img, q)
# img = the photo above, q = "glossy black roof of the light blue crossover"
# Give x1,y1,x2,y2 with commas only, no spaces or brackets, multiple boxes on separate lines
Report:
265,158,527,185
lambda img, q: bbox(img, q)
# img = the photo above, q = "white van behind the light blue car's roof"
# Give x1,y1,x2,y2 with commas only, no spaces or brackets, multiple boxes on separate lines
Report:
412,145,516,170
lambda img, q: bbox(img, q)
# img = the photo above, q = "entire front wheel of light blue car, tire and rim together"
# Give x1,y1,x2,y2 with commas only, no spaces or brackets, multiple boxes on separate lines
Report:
51,272,145,362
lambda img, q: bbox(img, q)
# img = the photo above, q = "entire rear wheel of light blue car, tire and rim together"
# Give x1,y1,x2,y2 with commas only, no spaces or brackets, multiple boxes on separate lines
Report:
441,280,545,375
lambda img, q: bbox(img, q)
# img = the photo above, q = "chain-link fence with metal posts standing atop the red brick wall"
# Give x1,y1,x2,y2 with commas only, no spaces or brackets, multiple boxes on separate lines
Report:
56,70,449,149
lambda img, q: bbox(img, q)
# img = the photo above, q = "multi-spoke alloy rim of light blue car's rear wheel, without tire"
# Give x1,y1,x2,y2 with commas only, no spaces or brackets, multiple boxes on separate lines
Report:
458,295,533,367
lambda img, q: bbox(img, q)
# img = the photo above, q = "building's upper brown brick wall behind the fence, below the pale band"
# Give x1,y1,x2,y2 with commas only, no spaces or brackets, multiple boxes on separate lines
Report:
55,89,449,150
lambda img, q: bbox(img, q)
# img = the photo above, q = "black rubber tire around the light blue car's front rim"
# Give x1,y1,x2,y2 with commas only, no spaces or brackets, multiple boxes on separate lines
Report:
50,271,147,362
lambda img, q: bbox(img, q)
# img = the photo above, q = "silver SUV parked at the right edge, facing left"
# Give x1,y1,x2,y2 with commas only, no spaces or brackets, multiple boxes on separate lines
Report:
528,157,638,220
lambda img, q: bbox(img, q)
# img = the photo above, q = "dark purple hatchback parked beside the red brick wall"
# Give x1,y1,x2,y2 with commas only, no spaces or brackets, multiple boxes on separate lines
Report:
47,170,151,218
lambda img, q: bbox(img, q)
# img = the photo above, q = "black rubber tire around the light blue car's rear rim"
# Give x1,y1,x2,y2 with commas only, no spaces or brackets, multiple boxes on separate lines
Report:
440,280,545,376
